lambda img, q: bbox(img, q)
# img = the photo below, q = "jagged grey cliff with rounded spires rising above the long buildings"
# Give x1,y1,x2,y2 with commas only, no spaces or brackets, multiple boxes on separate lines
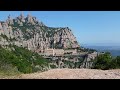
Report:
0,14,80,53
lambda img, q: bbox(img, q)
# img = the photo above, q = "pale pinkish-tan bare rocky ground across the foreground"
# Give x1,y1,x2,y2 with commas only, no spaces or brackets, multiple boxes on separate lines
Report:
1,69,120,79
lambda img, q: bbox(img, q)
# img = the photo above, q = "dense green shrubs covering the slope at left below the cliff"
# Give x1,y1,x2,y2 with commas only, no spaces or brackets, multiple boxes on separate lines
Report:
0,46,49,73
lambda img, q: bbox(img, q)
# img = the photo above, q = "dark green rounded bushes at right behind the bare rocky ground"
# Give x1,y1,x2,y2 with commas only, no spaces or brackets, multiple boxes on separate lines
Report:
92,52,120,70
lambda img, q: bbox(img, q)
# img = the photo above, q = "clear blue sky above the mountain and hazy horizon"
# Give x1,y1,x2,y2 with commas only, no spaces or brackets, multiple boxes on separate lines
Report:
0,11,120,45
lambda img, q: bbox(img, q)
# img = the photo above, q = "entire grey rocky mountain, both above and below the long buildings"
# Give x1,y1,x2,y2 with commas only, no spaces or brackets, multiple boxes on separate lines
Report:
0,14,98,68
